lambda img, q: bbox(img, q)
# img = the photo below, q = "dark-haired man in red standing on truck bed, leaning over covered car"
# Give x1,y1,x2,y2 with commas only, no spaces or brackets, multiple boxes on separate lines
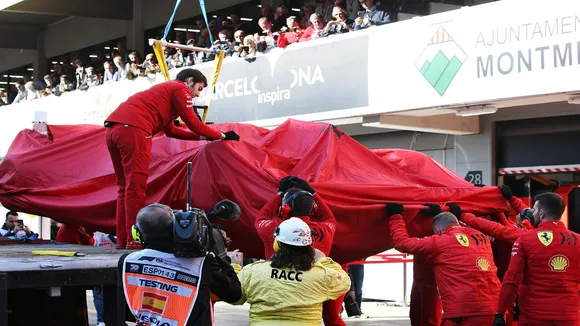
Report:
105,69,239,249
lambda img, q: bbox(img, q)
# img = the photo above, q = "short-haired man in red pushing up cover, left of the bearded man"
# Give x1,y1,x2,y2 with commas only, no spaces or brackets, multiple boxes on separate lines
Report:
387,203,500,326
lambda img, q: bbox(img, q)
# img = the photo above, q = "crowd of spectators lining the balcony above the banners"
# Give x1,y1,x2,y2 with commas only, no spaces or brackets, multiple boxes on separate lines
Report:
0,0,391,106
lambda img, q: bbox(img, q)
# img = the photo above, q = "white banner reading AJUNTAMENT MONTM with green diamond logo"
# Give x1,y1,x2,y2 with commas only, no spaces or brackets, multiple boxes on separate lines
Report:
364,0,580,113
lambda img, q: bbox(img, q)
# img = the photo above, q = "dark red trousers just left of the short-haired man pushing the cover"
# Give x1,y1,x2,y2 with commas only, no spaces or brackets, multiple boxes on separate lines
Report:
409,280,442,326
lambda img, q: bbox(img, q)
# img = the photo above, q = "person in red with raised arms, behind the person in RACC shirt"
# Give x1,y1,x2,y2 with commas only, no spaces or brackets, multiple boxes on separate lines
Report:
255,176,346,326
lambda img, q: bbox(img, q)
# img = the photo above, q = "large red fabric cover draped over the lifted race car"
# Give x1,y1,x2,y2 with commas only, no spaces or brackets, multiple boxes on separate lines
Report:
0,120,507,263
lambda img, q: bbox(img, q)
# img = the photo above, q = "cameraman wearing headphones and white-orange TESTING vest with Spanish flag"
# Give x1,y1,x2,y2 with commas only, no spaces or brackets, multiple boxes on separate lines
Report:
119,203,242,326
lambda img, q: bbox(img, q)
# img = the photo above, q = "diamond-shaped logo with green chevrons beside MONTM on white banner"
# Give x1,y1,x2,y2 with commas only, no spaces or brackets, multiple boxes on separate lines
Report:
415,26,467,96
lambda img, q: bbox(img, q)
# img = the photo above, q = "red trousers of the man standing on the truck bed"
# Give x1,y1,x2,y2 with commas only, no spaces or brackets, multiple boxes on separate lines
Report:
105,124,151,248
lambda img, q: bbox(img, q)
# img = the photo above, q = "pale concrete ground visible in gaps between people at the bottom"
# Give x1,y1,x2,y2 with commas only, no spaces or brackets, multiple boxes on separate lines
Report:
87,291,411,326
